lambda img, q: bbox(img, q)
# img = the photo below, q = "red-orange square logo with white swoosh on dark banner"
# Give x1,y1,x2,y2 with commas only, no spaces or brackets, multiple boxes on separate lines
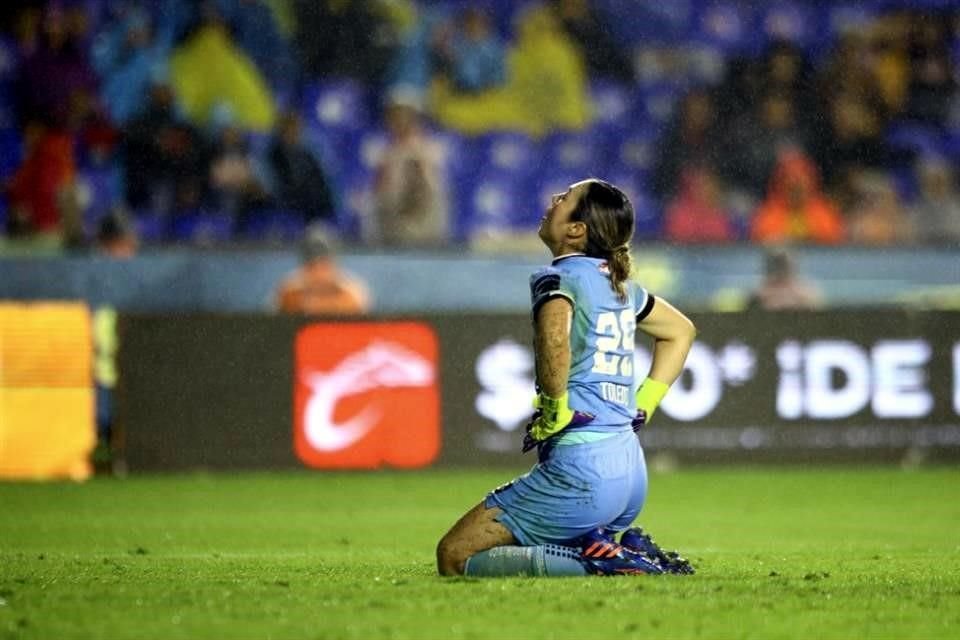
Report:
294,322,440,469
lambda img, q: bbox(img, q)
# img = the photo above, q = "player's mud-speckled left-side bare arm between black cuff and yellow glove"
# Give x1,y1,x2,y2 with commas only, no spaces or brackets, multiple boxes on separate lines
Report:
534,298,573,398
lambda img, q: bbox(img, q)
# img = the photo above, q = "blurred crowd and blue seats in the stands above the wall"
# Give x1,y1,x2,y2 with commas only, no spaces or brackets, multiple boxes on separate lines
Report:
0,0,960,248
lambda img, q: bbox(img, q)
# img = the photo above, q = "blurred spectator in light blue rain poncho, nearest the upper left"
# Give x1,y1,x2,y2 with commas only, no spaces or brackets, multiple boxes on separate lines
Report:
93,9,175,125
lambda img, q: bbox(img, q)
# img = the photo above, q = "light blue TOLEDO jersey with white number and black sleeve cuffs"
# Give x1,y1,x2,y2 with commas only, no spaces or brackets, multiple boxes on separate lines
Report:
530,254,653,431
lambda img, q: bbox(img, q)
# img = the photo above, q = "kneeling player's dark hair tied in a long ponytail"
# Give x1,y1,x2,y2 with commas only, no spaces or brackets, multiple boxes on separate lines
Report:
570,178,634,301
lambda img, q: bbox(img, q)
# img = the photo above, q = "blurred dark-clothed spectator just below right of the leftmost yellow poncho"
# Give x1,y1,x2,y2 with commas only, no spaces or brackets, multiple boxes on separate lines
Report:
268,112,336,223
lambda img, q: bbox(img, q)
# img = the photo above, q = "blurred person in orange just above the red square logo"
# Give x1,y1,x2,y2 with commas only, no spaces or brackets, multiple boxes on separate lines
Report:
275,229,370,315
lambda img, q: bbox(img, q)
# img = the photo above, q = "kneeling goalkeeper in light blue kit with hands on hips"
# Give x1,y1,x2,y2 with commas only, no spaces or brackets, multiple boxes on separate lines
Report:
437,179,696,576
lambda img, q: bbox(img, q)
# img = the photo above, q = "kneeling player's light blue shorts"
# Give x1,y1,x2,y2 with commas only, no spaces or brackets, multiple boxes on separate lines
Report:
484,430,647,545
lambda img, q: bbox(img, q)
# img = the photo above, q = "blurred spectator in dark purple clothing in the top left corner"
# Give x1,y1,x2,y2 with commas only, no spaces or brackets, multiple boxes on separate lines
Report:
17,3,97,126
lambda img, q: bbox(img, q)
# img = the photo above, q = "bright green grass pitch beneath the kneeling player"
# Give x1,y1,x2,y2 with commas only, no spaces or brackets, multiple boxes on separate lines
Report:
0,469,960,639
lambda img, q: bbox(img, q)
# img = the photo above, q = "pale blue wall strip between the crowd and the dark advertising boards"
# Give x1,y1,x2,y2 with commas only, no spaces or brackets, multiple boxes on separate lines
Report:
0,245,960,313
